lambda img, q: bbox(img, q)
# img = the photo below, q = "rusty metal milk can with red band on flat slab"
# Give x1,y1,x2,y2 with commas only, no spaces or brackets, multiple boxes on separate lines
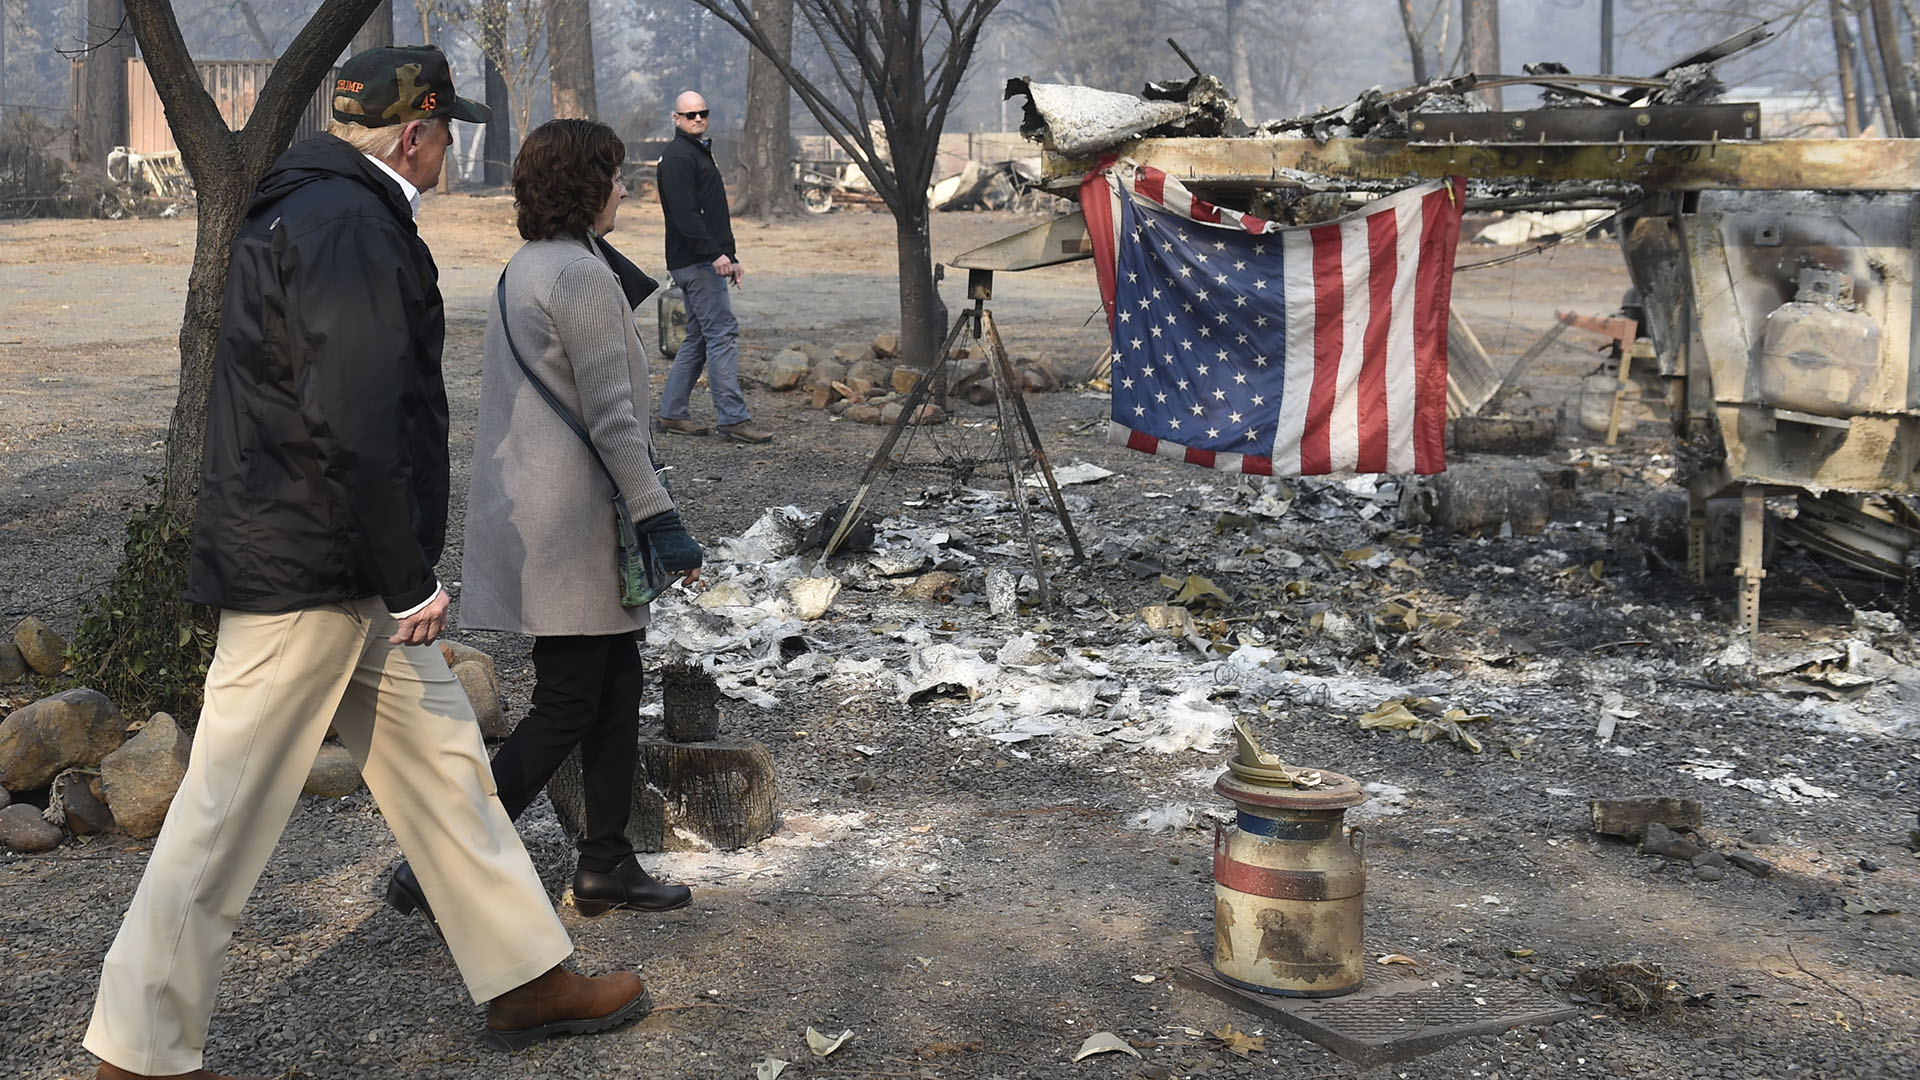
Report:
1213,724,1367,997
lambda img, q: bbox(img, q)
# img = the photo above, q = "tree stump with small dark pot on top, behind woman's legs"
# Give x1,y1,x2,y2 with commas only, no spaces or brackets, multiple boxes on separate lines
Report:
547,665,780,851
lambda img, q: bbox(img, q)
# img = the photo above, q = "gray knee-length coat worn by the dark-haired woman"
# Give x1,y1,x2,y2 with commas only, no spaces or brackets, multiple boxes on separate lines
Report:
461,238,674,636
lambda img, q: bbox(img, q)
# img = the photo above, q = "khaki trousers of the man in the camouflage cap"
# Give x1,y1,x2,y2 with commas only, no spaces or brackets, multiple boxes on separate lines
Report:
84,598,572,1074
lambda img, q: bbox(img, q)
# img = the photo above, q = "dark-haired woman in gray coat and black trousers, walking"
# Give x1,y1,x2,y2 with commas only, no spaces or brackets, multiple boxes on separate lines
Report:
388,119,701,919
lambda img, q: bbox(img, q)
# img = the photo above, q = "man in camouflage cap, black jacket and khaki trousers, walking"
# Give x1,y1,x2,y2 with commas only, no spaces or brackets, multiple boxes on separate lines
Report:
86,46,651,1080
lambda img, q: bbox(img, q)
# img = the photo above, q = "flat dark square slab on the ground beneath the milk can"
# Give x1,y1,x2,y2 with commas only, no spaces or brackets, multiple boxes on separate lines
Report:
1181,963,1578,1065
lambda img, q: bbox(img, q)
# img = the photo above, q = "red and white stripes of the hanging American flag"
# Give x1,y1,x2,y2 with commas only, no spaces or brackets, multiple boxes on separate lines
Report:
1081,161,1465,475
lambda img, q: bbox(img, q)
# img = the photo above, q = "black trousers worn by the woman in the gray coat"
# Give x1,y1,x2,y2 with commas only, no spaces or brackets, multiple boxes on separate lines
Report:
493,630,645,874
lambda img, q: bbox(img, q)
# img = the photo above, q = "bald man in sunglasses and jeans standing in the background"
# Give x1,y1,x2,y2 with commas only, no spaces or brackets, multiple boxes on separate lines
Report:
655,90,774,442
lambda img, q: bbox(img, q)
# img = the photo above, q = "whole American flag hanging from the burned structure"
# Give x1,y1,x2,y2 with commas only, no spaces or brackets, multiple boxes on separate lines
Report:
1081,161,1463,475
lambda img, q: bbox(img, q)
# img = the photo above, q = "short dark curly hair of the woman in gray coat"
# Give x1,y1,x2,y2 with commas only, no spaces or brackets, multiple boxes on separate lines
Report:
513,119,626,240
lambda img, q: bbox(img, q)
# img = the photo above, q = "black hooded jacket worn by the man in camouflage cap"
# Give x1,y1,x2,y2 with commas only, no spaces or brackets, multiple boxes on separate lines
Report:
186,135,447,613
